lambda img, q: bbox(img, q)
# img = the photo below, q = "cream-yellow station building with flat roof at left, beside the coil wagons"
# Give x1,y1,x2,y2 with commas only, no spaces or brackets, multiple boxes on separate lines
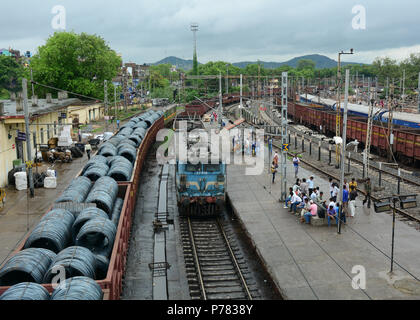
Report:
0,93,104,187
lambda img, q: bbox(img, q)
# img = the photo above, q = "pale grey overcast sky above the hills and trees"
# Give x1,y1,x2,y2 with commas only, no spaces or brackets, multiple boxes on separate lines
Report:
0,0,420,63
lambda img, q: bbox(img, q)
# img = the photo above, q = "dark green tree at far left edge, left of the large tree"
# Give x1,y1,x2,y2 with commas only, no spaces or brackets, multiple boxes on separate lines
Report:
0,55,24,92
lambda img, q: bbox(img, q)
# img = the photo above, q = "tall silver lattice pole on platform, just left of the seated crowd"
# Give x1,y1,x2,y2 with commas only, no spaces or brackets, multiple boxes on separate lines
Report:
280,72,289,201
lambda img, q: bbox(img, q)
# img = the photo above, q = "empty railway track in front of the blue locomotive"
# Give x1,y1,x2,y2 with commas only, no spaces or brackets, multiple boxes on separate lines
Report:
180,218,260,300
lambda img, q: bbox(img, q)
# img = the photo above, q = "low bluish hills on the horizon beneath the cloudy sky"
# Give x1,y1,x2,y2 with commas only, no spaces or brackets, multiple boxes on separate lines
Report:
152,54,359,70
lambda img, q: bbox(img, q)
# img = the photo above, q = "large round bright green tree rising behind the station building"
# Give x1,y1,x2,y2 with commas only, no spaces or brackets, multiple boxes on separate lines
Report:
31,32,122,99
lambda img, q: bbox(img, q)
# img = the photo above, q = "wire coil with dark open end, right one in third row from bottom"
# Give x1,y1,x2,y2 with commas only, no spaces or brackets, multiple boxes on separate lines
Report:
76,218,117,257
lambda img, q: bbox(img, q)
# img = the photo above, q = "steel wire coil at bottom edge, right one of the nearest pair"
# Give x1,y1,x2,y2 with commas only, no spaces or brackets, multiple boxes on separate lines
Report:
51,277,104,300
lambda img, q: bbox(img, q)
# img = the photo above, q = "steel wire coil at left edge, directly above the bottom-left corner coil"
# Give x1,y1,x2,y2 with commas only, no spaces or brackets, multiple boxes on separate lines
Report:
0,248,56,286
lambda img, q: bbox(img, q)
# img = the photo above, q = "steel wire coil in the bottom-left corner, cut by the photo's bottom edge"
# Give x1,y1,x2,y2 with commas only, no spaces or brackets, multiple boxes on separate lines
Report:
0,282,50,301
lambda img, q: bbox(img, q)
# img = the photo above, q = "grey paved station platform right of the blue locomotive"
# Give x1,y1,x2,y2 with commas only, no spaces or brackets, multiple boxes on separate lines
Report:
227,151,420,300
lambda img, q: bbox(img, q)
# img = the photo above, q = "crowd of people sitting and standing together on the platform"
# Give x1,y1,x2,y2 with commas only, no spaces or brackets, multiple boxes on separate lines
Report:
284,176,371,226
